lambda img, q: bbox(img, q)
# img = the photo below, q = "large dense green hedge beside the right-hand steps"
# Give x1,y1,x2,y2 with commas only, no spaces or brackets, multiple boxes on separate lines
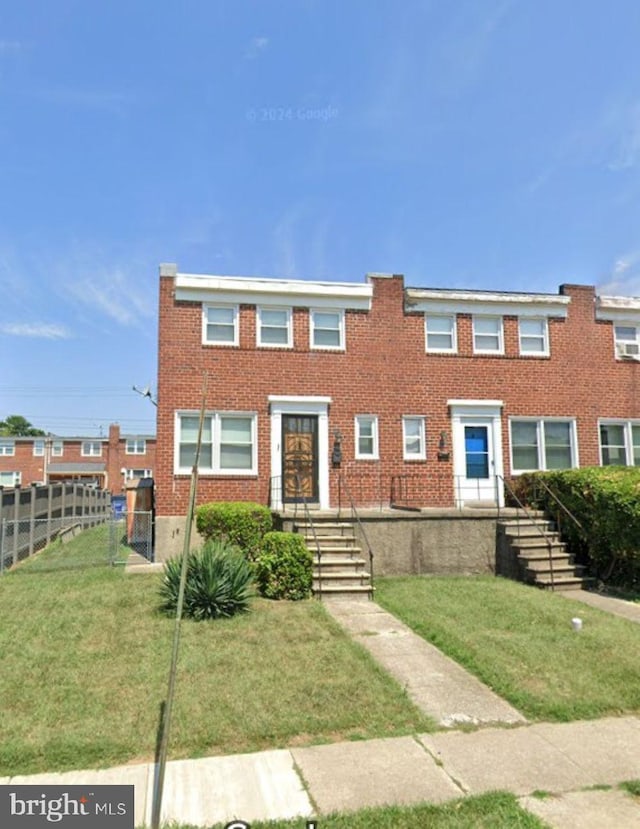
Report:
515,466,640,581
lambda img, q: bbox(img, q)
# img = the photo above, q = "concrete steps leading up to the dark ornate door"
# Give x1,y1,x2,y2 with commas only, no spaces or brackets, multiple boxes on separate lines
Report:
293,516,373,599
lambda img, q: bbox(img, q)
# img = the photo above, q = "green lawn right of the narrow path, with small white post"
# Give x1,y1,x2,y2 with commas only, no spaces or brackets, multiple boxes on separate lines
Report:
376,576,640,721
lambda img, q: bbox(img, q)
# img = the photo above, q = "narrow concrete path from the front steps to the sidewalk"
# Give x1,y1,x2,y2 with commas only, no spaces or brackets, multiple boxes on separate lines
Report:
324,599,526,727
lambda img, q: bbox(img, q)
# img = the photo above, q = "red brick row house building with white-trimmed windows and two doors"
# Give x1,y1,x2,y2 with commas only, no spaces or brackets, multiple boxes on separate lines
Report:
155,265,640,523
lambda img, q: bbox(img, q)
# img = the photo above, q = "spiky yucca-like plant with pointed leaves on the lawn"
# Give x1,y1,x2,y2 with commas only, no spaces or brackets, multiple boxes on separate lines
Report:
160,540,253,621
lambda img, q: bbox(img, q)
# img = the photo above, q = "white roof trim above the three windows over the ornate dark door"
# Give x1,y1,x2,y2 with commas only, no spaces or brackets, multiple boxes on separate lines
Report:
175,273,373,311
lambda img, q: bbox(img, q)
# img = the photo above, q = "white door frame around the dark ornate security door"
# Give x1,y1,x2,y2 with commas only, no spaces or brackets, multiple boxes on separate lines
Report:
268,394,331,510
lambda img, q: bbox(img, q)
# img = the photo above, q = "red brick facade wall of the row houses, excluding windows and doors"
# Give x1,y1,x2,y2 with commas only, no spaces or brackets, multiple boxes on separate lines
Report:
155,276,640,515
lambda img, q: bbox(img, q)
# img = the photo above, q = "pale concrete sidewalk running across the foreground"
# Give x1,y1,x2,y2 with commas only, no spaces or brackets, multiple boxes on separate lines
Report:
5,717,640,829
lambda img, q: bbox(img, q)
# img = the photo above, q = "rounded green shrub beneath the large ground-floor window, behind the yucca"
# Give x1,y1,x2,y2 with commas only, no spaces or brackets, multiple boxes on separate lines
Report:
196,501,273,561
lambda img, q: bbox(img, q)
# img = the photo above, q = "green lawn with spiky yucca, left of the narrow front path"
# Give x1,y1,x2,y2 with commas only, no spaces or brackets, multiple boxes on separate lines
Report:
0,528,433,776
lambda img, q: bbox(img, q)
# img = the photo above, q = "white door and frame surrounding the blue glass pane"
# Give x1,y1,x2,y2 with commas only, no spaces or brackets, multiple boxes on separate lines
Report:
447,400,504,507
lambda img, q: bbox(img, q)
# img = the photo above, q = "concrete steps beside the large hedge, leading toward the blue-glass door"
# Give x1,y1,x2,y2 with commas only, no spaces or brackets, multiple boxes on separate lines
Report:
498,517,593,590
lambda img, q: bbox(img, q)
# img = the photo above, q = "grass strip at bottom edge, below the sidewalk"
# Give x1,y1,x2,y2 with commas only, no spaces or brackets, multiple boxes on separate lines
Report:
160,792,546,829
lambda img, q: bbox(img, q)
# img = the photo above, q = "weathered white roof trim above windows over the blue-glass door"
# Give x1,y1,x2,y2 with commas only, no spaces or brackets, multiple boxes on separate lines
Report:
406,288,571,318
